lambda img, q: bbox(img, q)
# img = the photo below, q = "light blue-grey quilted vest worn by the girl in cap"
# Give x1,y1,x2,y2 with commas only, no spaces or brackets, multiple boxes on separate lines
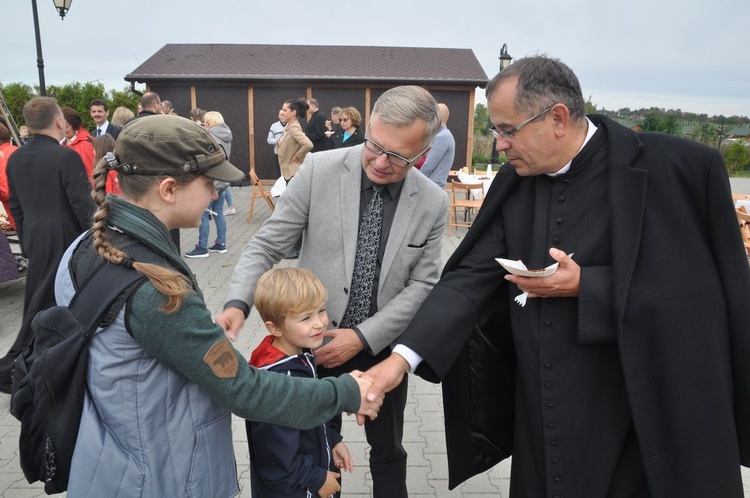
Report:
56,234,239,498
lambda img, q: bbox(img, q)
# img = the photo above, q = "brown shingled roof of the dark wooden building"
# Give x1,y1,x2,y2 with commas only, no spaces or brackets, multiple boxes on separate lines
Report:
125,44,487,87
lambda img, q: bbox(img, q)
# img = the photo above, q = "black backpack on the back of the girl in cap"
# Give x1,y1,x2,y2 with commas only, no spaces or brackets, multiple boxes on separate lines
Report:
10,256,146,494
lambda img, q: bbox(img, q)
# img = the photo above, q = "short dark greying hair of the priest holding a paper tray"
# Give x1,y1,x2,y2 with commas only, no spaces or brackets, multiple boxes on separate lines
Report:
485,55,586,125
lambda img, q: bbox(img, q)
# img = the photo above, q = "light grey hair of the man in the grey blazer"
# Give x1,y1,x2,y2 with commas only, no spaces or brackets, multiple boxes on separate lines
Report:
372,85,440,147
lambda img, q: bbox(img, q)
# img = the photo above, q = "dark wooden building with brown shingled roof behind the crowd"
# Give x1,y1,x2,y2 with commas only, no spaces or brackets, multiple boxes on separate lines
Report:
125,44,488,179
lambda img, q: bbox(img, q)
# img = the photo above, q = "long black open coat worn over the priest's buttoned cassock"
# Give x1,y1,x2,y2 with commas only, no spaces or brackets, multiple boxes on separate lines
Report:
400,116,750,497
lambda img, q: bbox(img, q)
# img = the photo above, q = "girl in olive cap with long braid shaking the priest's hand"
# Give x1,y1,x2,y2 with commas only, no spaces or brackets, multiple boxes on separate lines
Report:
56,116,381,497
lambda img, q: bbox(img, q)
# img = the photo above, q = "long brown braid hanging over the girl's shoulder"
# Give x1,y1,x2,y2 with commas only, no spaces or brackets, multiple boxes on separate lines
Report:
91,159,192,314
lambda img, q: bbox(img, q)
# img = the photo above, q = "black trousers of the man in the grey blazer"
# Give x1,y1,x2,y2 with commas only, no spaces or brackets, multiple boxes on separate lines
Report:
318,348,409,498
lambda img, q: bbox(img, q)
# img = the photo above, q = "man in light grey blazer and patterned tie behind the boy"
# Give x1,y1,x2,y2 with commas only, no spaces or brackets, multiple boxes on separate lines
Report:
216,86,448,498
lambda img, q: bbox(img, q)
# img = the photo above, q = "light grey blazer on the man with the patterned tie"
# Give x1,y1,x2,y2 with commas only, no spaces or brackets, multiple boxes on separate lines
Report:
227,145,448,354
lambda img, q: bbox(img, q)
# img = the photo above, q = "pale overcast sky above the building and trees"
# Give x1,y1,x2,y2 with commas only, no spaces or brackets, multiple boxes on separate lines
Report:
5,0,750,116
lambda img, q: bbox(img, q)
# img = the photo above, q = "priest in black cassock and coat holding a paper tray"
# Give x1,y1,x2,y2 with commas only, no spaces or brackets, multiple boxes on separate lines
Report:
365,57,750,498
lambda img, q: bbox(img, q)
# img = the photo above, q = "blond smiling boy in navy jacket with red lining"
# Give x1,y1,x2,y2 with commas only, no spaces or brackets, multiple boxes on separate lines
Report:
245,268,353,498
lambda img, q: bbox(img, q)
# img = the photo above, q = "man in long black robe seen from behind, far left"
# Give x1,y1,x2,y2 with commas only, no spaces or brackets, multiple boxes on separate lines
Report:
0,97,94,392
